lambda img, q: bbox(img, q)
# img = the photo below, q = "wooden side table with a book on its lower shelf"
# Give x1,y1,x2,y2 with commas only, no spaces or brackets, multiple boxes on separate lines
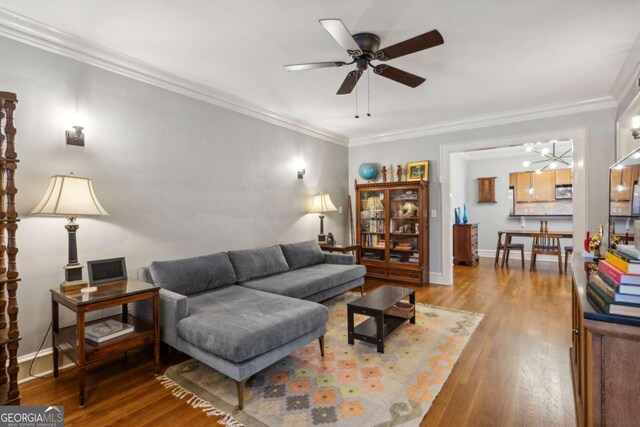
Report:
51,279,160,407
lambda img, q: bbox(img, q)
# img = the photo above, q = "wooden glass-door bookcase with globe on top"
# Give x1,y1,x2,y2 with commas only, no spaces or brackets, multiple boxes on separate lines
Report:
355,181,429,286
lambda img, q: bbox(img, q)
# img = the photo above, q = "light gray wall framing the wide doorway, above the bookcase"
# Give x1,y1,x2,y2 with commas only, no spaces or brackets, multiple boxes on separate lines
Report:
349,108,616,280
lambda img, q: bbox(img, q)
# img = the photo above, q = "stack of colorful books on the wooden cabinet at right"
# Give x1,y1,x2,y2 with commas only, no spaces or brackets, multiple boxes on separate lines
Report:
587,245,640,317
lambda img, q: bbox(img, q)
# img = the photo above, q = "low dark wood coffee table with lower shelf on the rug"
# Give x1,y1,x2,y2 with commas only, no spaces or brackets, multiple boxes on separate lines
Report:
347,285,416,353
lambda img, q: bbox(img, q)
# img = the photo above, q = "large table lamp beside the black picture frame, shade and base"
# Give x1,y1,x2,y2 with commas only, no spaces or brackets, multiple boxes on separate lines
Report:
31,174,109,290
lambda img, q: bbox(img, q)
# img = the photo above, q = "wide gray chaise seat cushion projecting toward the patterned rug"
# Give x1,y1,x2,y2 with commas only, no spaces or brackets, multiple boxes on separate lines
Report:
178,285,329,363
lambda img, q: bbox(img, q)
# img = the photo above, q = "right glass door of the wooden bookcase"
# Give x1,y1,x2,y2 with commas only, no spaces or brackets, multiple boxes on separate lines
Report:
389,189,423,265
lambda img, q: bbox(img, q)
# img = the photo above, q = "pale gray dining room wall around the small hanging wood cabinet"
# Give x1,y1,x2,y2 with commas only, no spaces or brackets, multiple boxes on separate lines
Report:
466,157,573,256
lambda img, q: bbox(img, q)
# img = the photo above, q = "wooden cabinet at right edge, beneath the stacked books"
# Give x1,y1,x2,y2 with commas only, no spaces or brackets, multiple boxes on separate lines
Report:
570,254,640,426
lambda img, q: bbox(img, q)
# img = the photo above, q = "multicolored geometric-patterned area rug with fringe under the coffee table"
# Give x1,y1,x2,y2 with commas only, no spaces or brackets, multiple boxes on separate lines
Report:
159,294,483,427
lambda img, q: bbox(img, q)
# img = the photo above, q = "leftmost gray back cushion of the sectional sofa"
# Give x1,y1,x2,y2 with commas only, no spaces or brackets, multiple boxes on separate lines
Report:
149,252,237,295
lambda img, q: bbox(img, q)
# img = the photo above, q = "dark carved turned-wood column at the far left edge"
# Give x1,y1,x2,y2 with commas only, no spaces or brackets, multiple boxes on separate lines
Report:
0,92,20,405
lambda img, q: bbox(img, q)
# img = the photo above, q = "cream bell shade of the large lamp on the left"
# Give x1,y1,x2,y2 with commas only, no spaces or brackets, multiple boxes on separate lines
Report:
31,175,109,216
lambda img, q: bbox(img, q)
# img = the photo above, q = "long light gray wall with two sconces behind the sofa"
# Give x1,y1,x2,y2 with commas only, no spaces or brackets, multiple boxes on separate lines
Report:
0,38,349,354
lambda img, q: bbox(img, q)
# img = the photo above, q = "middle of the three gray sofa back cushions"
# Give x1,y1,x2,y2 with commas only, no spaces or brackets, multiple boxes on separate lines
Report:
227,245,289,281
